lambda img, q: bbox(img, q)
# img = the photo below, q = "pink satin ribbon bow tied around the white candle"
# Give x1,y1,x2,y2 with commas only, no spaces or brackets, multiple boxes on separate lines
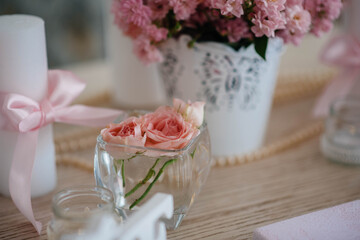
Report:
0,70,121,234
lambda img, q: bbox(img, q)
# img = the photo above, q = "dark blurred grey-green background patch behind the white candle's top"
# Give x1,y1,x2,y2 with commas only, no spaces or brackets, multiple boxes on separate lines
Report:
0,0,107,68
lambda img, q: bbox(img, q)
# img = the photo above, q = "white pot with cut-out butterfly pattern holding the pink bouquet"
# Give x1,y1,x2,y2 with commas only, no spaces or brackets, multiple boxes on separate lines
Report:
159,36,283,156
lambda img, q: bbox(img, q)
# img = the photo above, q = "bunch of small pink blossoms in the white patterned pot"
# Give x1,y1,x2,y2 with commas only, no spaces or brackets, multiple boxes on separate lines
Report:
112,0,342,63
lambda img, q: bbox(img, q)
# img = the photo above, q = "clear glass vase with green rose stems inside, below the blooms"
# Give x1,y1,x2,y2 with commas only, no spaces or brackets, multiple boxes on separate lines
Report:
94,111,211,230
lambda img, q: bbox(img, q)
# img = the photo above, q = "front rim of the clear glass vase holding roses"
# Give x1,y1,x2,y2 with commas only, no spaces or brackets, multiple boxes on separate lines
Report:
96,121,207,153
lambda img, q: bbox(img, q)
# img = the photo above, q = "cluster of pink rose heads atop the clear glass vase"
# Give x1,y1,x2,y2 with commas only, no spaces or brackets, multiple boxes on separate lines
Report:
101,99,205,154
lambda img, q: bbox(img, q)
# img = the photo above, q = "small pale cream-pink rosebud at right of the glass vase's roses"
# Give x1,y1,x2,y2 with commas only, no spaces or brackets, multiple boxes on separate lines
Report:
173,98,205,127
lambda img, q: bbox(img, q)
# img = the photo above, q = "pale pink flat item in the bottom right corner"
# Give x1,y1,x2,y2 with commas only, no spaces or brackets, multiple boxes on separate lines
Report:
253,200,360,240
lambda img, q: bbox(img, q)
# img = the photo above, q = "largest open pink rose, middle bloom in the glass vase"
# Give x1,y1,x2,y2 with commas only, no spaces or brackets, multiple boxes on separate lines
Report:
144,107,200,150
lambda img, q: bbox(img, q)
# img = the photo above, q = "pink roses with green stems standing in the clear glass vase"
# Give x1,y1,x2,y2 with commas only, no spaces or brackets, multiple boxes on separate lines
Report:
101,99,205,209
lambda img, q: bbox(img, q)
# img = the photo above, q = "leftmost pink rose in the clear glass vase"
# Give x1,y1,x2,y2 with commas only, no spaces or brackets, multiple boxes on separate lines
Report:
101,117,146,147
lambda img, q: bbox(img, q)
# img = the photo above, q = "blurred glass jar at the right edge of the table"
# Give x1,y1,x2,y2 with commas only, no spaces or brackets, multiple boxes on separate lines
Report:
321,97,360,164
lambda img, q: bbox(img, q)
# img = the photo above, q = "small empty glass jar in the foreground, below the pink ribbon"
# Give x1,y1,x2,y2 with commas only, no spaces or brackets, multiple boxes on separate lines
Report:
47,186,115,240
